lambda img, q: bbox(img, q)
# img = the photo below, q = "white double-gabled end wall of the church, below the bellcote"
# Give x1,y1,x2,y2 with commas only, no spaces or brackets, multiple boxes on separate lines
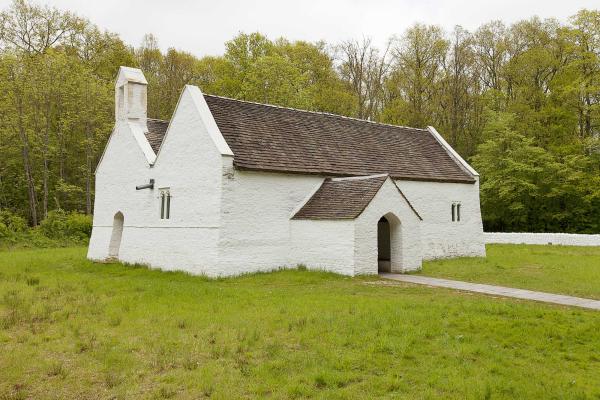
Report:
88,87,231,276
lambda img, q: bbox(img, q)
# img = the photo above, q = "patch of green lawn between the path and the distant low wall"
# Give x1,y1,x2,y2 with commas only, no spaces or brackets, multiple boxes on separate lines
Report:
421,244,600,299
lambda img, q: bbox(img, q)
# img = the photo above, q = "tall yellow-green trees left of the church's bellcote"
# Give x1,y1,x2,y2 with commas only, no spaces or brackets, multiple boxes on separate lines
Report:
0,0,134,225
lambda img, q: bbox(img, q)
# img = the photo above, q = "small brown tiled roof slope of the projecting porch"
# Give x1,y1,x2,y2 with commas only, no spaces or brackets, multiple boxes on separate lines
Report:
292,175,388,219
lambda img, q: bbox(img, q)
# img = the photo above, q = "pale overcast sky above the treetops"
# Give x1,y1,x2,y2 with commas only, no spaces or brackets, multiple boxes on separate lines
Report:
0,0,600,56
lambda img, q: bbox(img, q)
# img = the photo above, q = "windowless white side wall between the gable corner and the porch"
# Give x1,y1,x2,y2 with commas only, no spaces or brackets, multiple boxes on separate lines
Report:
219,170,323,275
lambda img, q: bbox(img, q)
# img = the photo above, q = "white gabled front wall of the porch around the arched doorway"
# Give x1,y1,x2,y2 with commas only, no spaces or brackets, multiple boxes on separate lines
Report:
354,179,422,275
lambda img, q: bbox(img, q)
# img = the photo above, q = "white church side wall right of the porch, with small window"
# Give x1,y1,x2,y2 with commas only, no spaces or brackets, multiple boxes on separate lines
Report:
396,181,485,260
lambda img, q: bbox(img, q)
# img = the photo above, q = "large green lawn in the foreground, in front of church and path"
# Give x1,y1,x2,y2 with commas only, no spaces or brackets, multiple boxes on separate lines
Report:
0,246,600,399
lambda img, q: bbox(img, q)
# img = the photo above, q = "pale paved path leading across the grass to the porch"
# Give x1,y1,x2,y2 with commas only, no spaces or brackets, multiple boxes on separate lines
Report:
379,273,600,310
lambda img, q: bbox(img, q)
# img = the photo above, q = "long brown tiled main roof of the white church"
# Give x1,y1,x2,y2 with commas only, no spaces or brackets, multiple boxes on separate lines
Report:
142,95,475,183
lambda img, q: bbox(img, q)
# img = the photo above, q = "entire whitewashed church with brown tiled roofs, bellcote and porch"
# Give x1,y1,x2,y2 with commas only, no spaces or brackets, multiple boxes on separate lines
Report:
88,67,485,276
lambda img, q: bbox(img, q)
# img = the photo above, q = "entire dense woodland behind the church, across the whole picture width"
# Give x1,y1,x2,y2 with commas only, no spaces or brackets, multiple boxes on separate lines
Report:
0,0,600,233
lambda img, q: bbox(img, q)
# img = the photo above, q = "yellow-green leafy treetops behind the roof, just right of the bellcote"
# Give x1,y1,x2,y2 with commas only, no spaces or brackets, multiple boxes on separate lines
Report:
136,33,353,119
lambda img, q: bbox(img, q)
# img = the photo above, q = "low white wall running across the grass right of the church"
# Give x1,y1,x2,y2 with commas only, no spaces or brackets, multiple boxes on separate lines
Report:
483,232,600,246
